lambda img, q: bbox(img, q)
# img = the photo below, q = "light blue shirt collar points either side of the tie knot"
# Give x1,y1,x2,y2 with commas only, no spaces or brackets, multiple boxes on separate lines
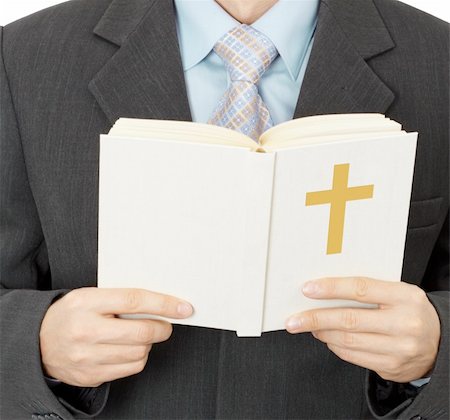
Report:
175,0,319,80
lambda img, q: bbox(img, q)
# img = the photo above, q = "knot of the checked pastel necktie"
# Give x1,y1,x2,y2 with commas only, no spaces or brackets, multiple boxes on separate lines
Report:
214,24,278,83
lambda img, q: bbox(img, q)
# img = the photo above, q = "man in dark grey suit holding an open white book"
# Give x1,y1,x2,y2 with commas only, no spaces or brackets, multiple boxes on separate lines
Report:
1,0,449,419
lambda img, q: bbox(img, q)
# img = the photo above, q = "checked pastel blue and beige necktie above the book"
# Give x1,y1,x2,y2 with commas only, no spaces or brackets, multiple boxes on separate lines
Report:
208,25,278,141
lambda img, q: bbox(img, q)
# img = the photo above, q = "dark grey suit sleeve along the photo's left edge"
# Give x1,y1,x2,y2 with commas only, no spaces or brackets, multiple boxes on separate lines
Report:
0,27,106,419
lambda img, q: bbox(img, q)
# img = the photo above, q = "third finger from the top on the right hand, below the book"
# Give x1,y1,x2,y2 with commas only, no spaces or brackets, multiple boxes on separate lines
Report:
312,330,400,355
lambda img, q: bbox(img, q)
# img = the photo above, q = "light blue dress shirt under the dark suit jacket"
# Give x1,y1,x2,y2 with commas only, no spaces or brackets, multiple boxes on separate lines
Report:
175,0,319,124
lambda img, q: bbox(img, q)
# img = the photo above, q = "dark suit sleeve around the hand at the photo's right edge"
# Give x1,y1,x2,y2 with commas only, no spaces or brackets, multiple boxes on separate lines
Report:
366,213,450,420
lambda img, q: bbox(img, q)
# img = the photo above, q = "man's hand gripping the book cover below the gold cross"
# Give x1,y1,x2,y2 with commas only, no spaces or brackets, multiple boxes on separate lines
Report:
286,277,440,382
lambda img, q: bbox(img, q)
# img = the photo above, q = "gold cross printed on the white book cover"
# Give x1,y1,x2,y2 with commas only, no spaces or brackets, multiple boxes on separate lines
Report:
305,163,374,254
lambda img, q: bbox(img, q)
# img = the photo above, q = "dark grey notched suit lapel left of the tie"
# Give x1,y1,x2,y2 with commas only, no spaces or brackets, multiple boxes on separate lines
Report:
89,0,191,123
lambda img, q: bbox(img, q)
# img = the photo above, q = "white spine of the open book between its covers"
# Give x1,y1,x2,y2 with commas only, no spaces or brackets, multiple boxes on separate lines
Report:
236,153,275,337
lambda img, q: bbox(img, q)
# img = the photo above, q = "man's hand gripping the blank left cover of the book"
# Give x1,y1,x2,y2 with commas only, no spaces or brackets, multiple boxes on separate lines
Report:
40,288,192,387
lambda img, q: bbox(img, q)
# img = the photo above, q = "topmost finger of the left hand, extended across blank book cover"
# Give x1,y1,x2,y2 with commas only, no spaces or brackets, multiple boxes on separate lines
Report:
86,289,193,319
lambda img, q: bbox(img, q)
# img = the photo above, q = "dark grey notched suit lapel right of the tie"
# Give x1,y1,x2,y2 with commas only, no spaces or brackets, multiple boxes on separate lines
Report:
294,0,394,118
